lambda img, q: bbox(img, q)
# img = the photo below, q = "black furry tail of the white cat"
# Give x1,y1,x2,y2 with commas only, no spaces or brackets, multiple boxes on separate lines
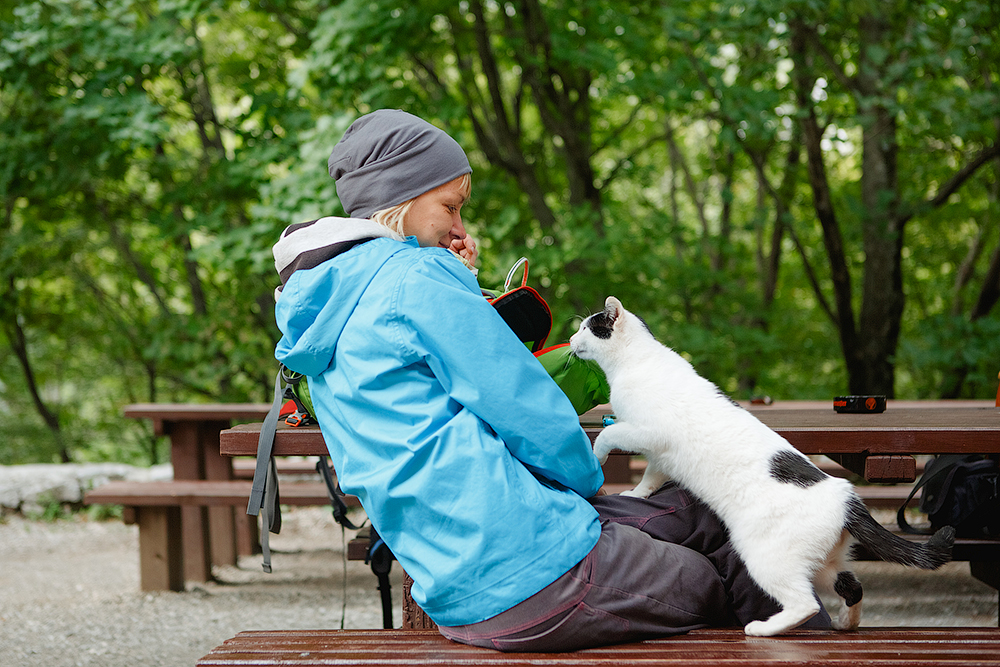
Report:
845,495,955,570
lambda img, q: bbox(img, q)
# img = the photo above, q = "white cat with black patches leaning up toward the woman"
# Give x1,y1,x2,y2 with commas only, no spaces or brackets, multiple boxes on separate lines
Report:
570,296,955,636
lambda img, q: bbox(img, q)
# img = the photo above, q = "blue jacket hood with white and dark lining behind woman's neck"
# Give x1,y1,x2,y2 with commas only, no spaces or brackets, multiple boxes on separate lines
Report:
274,217,408,376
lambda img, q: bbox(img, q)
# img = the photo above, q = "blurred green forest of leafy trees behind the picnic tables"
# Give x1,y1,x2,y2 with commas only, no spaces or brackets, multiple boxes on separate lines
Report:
0,0,1000,465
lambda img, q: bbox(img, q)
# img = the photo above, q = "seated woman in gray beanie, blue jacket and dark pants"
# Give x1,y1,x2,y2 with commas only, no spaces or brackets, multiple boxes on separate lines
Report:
274,110,828,651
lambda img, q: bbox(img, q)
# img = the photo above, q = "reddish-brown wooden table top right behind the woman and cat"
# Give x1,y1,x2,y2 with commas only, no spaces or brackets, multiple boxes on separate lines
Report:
220,401,1000,456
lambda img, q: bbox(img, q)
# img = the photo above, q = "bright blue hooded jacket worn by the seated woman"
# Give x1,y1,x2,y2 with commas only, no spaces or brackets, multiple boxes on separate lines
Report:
275,227,604,626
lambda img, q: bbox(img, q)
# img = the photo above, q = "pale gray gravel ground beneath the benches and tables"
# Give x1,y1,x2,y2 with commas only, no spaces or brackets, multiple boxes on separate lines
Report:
0,508,997,667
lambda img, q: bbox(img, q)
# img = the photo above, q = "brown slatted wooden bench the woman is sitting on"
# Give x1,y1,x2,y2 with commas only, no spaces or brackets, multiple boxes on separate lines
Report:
197,628,1000,667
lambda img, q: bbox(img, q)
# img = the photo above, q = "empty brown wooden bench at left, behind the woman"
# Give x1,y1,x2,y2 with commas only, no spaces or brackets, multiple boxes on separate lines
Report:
83,480,359,591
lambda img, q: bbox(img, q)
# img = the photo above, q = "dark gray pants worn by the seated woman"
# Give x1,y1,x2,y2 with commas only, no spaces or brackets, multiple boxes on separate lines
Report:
440,483,830,651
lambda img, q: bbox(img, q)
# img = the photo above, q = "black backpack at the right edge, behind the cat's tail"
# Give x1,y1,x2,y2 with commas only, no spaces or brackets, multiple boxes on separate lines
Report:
896,454,1000,538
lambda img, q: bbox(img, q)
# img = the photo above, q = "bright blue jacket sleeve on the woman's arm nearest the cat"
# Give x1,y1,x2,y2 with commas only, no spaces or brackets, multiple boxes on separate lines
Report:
392,249,604,498
